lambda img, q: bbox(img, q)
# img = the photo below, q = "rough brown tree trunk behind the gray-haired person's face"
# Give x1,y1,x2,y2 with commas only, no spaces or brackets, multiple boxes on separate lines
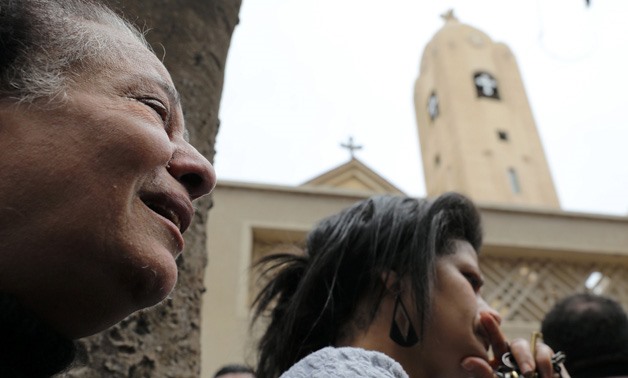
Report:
62,0,241,378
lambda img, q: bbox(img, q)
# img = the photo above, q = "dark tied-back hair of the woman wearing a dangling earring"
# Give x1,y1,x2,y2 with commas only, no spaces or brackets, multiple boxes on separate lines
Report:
253,193,482,378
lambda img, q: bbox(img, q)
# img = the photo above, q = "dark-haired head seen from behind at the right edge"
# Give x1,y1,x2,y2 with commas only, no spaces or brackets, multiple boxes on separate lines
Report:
541,293,628,378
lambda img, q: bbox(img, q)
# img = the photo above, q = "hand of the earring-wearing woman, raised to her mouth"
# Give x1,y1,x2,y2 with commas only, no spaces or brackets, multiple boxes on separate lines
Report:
461,313,569,378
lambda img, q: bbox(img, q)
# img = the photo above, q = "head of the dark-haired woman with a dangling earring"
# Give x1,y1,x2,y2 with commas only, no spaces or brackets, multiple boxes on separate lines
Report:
256,193,498,378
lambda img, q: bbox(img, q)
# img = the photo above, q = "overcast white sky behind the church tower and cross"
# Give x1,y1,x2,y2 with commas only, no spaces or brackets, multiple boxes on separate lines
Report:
215,0,628,215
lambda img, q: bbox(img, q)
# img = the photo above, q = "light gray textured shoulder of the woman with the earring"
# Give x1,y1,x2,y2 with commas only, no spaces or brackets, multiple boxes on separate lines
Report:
281,347,408,378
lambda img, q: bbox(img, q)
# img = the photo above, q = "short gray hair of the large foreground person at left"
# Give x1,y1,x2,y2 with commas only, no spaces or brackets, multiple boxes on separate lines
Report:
0,0,150,103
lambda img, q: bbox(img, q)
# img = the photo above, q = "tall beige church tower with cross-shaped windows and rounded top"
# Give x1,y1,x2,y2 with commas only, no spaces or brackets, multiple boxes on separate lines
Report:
414,11,560,208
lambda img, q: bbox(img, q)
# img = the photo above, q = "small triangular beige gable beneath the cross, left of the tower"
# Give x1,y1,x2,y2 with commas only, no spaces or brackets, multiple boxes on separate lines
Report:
300,158,404,194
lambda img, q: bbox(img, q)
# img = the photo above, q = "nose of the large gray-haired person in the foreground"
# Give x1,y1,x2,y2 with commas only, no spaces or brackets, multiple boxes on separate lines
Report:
168,142,216,200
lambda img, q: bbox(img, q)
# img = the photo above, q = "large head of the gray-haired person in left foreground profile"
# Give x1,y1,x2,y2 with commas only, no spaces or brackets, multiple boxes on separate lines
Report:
0,0,216,338
